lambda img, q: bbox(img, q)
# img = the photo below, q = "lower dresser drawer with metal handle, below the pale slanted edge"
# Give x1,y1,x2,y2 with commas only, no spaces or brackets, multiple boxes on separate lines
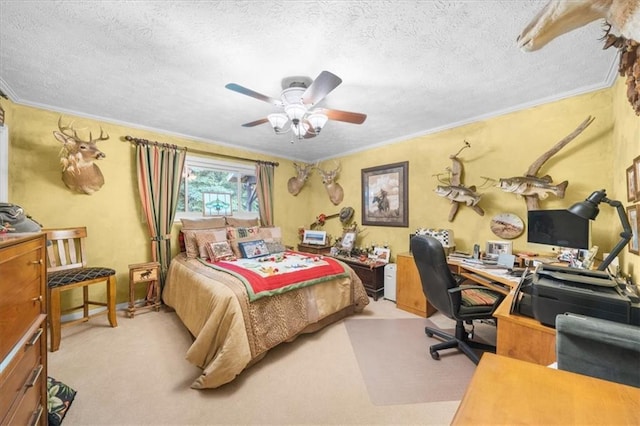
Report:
0,322,46,413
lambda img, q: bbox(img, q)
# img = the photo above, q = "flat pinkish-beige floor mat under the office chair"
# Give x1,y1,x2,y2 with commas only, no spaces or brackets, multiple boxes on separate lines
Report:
345,318,475,405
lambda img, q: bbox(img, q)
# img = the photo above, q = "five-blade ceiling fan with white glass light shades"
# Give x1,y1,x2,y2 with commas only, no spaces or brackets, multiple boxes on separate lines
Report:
225,71,367,139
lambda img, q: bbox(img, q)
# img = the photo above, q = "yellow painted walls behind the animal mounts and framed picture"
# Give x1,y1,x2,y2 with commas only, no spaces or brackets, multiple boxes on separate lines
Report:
0,77,640,310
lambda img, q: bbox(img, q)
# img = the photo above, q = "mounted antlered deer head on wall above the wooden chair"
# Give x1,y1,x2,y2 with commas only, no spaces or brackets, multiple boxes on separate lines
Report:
53,117,109,195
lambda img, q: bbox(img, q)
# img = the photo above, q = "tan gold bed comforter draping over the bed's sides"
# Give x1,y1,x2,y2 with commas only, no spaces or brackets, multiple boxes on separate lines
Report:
163,253,369,389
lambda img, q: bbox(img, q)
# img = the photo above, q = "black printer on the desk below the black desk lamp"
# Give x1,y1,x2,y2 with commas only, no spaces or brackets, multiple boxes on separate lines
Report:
514,265,640,327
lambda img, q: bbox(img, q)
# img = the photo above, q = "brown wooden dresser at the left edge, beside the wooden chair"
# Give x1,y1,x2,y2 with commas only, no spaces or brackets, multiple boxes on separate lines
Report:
0,233,47,426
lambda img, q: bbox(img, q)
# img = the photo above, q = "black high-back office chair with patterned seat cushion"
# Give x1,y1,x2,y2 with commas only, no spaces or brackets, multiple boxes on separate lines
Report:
411,235,504,364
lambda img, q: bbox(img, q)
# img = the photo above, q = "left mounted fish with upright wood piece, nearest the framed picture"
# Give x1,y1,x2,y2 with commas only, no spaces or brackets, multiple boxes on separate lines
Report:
435,141,484,222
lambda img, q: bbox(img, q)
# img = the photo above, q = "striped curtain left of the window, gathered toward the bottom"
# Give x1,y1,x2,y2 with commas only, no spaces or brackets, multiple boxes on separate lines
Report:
136,142,187,294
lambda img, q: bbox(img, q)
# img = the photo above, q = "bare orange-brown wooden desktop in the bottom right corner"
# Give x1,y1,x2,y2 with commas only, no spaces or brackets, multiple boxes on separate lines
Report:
452,353,640,425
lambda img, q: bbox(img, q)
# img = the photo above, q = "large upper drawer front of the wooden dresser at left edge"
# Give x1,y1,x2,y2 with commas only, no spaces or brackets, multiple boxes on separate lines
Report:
0,240,46,359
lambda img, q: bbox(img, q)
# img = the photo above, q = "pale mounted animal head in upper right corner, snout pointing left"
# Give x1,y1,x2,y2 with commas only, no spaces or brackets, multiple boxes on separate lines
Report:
518,0,640,52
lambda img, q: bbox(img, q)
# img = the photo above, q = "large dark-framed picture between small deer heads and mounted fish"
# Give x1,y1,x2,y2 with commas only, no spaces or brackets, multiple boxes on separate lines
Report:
362,161,409,227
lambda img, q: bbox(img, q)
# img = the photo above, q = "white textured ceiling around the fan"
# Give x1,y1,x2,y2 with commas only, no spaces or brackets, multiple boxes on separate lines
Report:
0,0,617,162
